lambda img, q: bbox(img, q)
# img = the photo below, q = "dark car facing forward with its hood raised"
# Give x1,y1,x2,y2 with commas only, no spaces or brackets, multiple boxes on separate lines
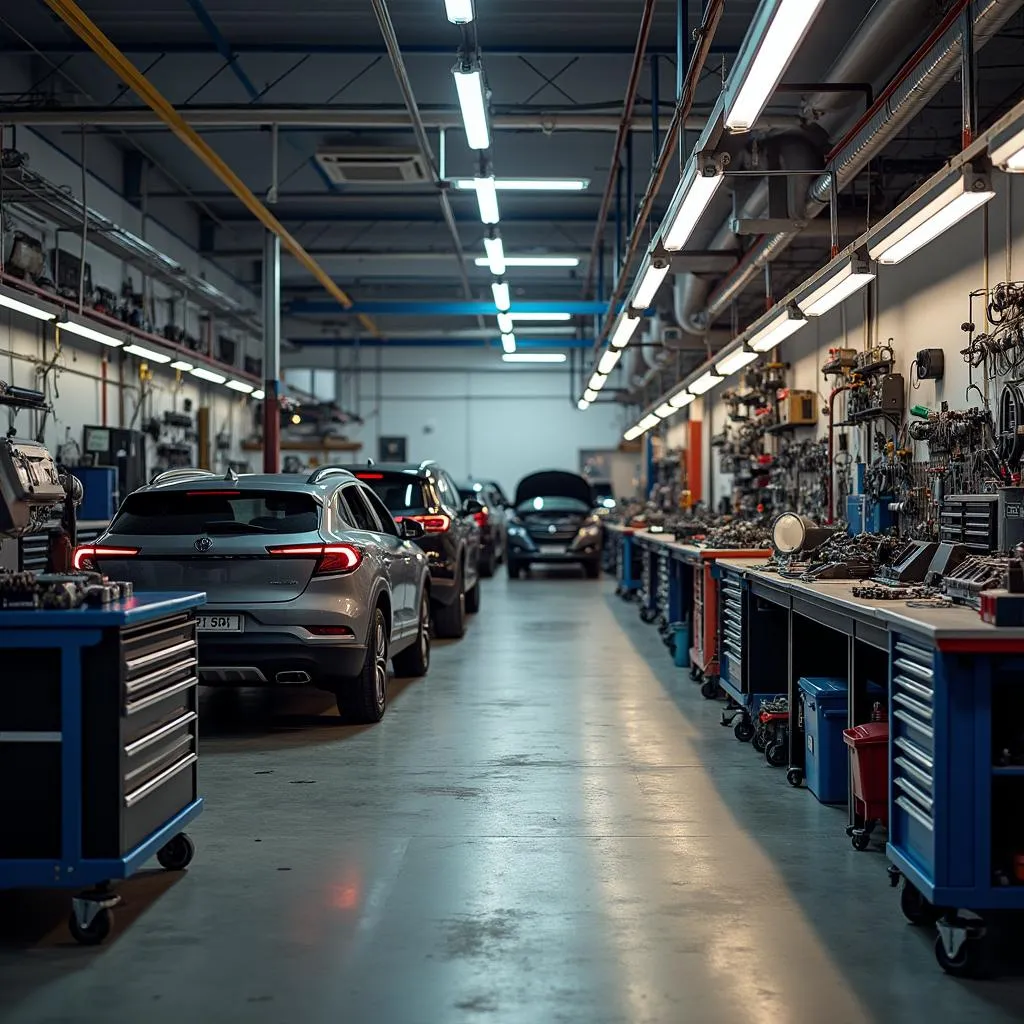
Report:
507,469,602,580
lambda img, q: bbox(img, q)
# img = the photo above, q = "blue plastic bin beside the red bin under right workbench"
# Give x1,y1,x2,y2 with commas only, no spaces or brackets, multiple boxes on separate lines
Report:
798,676,849,804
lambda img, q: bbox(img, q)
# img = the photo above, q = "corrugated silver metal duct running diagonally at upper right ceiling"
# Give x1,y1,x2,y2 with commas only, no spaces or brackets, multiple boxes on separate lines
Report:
699,0,1024,324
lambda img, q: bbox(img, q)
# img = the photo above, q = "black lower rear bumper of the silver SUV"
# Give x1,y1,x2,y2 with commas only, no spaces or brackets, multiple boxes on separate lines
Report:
199,633,367,687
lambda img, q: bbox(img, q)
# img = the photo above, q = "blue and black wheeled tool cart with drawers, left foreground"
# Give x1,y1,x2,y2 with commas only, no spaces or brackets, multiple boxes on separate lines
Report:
0,593,206,944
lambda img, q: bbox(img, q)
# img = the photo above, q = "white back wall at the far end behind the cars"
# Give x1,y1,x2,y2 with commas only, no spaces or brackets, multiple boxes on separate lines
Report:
284,346,624,490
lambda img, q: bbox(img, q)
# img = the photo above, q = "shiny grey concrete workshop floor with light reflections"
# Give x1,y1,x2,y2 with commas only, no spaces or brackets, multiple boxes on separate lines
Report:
0,575,1024,1024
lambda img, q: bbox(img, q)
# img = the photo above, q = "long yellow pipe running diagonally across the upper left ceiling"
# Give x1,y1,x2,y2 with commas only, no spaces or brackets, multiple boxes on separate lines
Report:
45,0,380,338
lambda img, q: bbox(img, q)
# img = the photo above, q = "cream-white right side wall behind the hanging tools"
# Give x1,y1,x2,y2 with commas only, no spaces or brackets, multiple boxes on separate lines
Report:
694,172,1024,512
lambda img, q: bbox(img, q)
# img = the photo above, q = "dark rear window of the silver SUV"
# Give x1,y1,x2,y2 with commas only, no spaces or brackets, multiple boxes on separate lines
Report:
111,490,319,537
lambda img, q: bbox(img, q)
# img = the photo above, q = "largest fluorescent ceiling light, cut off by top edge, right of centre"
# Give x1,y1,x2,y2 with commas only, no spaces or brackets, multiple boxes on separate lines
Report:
725,0,822,132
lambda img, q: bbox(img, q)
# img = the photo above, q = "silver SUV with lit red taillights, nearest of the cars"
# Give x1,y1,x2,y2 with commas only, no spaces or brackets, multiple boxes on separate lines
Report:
74,467,430,722
